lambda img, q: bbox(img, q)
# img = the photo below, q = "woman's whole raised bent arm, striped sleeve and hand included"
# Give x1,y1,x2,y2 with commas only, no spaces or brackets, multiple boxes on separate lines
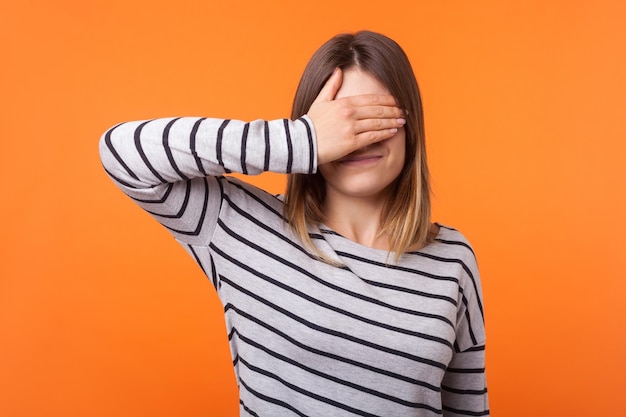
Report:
100,70,404,245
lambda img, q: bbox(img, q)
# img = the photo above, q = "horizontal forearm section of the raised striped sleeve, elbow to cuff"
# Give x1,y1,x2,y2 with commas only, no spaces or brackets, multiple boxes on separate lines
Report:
100,117,316,189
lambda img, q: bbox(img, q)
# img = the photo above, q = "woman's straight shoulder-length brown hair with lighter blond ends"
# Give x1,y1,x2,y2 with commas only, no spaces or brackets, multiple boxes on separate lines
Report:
283,31,431,262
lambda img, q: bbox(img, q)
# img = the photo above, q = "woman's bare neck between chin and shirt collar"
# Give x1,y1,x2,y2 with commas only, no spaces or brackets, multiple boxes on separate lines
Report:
323,192,390,250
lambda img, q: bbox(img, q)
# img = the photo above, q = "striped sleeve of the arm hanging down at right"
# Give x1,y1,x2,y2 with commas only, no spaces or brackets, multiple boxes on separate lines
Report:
441,251,489,417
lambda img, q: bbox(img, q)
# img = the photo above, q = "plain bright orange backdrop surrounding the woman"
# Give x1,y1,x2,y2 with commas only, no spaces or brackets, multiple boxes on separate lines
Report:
0,0,626,417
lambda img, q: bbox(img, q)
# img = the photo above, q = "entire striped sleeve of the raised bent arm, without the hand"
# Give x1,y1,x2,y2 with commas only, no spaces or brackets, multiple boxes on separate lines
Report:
100,116,317,246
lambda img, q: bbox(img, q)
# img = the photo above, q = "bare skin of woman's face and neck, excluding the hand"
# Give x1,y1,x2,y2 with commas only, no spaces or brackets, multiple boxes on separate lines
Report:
318,67,405,250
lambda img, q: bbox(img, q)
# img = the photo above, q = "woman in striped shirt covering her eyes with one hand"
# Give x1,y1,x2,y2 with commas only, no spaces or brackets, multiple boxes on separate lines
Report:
100,32,489,416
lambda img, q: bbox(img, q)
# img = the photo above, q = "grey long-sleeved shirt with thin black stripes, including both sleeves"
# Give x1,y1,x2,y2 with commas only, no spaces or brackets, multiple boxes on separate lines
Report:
100,116,489,417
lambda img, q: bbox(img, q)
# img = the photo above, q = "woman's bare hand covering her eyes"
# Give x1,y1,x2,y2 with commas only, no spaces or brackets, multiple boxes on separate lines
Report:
307,68,406,165
